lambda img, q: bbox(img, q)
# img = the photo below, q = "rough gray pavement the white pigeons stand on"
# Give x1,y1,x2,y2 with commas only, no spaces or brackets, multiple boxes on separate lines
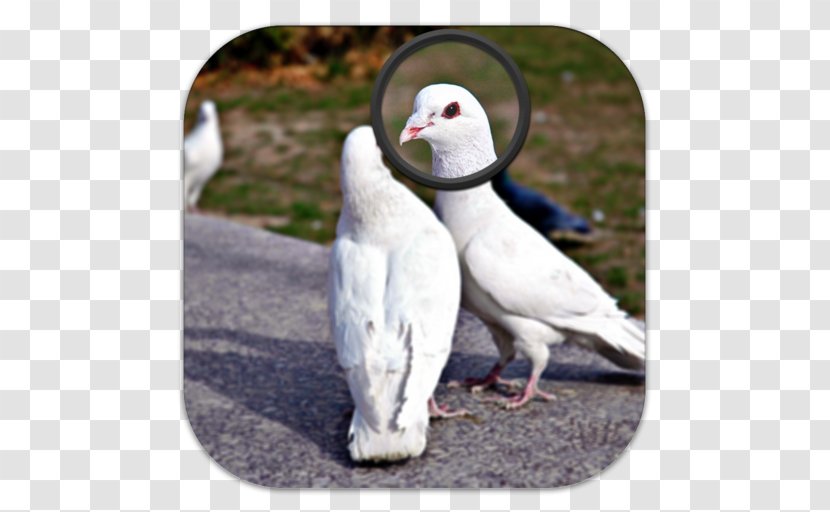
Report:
184,216,645,488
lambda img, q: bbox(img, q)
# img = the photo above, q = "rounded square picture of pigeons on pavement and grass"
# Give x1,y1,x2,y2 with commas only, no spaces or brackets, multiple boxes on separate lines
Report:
182,27,646,488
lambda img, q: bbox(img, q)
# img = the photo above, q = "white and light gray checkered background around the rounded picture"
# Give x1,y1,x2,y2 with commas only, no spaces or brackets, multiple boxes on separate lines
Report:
0,0,830,511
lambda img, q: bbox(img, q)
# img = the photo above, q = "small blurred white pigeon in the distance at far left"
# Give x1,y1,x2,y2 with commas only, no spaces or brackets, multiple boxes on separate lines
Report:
184,100,222,211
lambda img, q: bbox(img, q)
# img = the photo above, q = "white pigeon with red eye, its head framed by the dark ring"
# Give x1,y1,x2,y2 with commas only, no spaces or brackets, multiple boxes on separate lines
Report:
400,84,645,408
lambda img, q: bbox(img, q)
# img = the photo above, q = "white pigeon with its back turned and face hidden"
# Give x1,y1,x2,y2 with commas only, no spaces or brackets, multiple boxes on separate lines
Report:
329,126,466,461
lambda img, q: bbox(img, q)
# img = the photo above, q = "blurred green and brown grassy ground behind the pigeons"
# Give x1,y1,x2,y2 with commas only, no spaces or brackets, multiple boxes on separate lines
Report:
184,27,645,316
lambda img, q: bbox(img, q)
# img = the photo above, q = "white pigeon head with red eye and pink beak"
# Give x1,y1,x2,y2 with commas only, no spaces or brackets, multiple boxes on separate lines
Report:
399,84,491,151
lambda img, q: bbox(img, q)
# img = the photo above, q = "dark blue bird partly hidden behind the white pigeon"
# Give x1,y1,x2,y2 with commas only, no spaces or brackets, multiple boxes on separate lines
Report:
493,169,591,241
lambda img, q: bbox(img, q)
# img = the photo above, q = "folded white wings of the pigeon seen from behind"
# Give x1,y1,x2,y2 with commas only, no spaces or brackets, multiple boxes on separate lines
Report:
329,221,460,431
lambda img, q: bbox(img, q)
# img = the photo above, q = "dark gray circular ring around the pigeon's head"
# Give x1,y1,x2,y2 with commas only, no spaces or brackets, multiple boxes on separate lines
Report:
371,29,530,190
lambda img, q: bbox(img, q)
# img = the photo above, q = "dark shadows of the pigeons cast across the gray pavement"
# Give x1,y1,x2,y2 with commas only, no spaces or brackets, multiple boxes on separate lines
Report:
184,328,643,467
